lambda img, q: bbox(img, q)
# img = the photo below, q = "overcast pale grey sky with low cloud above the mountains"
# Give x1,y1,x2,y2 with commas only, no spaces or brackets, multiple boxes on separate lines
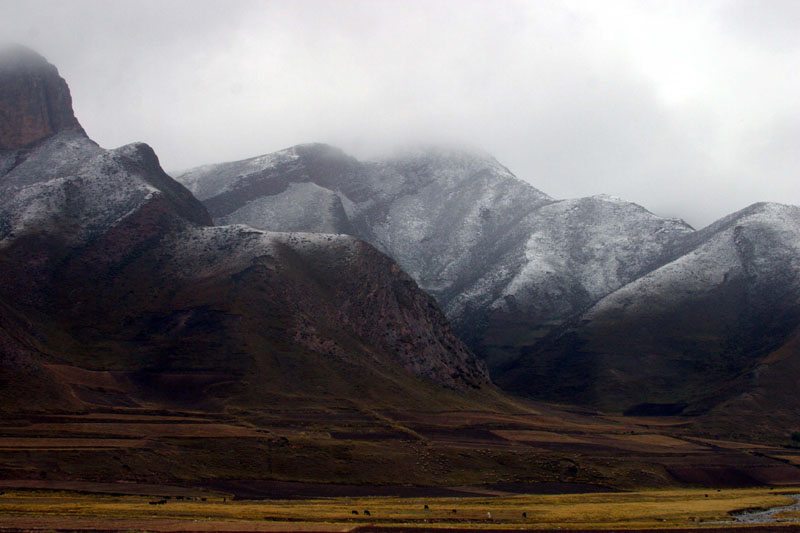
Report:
0,0,800,227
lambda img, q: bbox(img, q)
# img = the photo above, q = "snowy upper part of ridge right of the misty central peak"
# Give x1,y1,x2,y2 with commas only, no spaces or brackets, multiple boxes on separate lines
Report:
448,196,693,317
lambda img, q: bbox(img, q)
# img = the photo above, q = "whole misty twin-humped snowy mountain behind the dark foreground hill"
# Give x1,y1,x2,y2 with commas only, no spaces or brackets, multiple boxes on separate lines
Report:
177,145,551,296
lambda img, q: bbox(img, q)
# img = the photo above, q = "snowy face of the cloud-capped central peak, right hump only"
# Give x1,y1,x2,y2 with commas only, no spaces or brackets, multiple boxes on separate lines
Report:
354,150,552,294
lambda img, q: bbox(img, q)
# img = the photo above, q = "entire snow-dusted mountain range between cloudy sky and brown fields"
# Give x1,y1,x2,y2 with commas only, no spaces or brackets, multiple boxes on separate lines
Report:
0,44,800,448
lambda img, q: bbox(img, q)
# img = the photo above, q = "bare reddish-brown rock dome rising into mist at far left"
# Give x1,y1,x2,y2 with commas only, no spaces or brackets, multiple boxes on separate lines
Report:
0,47,83,150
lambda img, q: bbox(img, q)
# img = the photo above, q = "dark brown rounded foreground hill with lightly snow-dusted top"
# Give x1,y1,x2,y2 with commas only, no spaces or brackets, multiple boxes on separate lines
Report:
29,219,488,400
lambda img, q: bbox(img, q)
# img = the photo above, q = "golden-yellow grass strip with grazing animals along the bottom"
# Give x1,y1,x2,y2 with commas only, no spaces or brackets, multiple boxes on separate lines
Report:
0,488,800,531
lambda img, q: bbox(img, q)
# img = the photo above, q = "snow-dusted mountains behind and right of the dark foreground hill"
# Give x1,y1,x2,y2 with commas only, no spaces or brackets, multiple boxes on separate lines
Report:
177,139,800,426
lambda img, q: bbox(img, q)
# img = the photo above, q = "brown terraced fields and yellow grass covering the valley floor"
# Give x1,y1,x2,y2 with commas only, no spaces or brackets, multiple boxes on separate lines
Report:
0,405,800,533
